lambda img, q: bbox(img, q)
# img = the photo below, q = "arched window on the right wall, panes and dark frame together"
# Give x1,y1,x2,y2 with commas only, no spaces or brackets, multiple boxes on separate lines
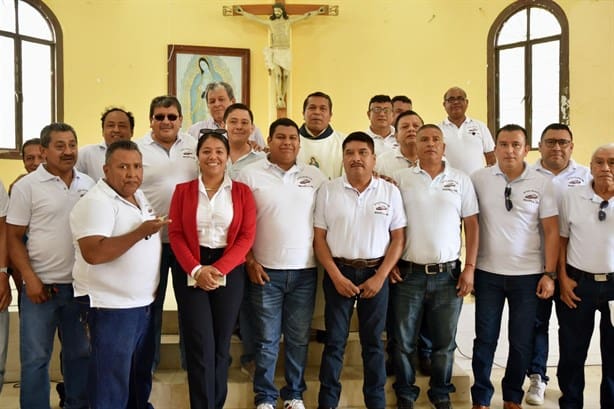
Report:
488,0,569,148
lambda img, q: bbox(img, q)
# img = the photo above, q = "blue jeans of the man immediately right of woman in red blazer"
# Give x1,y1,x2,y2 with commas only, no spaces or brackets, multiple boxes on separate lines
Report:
247,268,317,406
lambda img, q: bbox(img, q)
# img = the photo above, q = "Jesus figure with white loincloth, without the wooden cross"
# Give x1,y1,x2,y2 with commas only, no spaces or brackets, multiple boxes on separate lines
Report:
233,3,324,108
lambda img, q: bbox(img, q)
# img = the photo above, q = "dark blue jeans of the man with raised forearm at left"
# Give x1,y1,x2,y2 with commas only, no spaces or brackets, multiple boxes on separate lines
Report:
87,306,154,409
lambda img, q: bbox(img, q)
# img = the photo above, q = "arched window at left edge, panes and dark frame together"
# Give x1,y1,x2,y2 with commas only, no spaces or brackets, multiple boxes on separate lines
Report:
0,0,63,158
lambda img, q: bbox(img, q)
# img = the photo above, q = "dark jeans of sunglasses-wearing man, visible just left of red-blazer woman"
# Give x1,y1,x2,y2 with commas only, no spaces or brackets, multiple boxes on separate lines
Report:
152,243,186,371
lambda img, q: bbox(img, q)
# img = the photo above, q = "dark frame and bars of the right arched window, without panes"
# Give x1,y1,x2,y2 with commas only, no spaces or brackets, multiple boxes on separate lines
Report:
487,0,570,150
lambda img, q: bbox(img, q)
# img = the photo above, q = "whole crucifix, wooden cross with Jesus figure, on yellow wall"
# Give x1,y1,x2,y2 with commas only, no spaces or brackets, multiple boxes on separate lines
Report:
222,0,339,117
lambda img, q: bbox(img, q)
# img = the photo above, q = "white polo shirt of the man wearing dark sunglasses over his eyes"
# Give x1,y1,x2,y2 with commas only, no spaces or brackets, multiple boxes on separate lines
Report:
136,132,198,243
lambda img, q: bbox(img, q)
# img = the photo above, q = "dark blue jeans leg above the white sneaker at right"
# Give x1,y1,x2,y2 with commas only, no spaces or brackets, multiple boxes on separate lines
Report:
527,292,558,383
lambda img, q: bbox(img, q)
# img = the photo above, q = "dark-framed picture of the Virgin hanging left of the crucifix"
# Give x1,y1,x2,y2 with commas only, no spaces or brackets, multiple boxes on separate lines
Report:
167,44,250,128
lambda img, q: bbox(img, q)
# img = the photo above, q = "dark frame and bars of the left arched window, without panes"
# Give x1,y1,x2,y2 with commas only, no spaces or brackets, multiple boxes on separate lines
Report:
0,0,64,159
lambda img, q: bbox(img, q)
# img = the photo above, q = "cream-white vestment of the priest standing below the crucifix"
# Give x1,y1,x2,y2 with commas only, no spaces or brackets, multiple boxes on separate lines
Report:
296,127,345,179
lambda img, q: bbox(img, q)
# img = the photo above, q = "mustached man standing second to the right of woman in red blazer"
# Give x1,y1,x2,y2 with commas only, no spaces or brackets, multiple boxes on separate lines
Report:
314,132,407,409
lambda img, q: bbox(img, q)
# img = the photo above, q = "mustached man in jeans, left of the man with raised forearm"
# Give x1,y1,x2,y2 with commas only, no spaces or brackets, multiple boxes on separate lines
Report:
6,123,94,409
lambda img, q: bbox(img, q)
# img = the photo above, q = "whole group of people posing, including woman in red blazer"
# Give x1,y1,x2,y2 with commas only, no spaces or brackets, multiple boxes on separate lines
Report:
0,82,614,409
